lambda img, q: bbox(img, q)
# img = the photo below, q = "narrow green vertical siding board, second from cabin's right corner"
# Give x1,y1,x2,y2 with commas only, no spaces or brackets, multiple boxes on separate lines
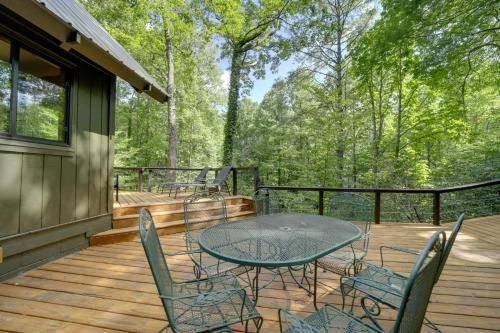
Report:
89,72,104,216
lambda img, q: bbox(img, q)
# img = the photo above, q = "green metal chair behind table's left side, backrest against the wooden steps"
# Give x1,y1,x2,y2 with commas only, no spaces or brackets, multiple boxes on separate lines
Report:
184,192,248,278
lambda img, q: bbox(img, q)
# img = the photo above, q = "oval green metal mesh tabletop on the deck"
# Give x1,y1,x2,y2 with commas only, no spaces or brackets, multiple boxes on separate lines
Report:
198,214,361,267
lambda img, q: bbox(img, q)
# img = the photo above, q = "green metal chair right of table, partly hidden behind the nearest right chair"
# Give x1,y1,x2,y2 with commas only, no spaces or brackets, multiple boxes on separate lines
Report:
341,214,464,331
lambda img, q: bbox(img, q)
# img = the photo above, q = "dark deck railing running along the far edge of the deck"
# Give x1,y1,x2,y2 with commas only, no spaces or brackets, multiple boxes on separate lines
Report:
114,167,500,225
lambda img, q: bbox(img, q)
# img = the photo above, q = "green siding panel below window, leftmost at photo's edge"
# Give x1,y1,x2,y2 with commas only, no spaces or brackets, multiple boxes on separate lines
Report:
0,152,23,236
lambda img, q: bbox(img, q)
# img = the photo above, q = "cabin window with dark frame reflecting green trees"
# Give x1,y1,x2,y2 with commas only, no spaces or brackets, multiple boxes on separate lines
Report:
0,36,69,143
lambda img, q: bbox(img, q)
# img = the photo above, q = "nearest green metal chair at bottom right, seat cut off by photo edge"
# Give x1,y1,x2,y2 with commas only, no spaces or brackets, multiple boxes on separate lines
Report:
279,231,446,333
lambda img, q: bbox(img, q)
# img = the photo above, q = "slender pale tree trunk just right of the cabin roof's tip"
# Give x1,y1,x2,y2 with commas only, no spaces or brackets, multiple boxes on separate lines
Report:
165,29,177,182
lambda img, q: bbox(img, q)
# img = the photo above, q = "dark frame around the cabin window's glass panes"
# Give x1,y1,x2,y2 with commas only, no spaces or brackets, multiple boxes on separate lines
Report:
0,33,74,147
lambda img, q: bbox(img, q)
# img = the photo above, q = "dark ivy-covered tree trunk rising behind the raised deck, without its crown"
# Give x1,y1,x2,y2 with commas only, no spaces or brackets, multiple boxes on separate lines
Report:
222,48,243,165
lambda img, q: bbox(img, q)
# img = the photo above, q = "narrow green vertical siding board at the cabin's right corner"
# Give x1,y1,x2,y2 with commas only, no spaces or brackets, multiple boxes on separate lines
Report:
99,77,111,214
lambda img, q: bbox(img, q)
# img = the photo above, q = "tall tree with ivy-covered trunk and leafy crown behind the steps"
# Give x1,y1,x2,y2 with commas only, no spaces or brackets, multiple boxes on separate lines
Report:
206,0,290,164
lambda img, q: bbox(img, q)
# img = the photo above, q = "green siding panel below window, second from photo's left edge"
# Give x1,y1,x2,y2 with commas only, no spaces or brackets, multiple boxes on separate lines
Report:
20,154,43,232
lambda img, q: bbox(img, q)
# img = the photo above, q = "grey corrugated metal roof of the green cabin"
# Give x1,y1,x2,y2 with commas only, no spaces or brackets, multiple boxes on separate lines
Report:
35,0,164,99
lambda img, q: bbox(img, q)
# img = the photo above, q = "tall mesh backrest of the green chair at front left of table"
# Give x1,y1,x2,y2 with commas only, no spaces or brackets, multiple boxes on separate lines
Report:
139,208,174,296
